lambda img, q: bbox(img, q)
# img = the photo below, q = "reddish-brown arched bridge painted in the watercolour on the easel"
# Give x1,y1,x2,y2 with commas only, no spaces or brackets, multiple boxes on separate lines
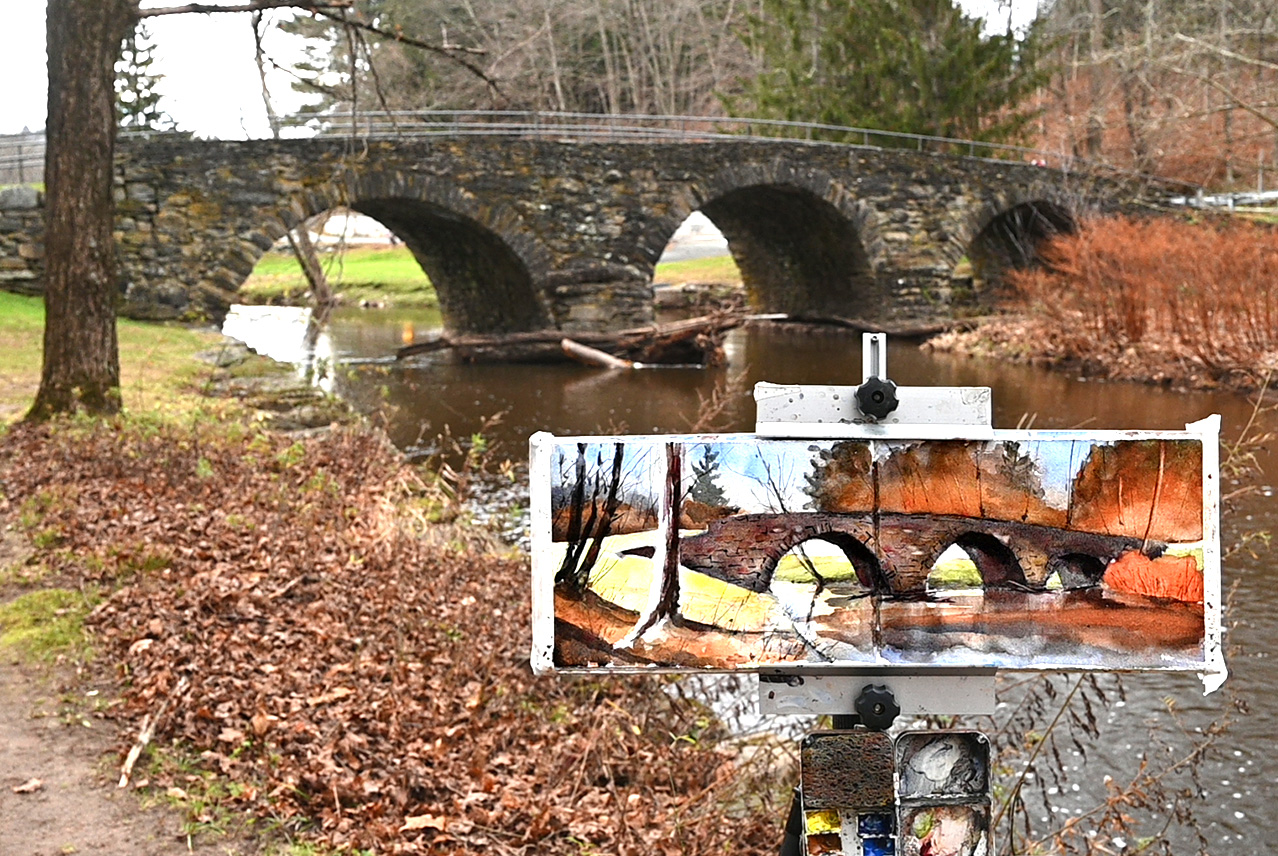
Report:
679,511,1160,594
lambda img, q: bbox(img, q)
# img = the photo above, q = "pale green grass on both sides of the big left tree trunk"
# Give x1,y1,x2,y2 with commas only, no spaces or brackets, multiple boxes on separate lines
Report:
0,291,235,424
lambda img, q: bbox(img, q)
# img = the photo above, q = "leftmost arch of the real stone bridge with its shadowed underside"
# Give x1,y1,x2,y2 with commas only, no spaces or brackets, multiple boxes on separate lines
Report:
260,172,552,333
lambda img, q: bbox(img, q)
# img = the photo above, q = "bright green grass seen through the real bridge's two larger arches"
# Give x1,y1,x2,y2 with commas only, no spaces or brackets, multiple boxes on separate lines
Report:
240,247,741,307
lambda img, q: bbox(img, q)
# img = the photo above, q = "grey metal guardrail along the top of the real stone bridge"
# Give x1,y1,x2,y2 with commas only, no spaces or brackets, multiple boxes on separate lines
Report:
0,110,1200,193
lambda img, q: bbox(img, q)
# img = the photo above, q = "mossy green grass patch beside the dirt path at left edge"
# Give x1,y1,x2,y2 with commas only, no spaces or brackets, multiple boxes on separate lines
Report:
0,589,96,661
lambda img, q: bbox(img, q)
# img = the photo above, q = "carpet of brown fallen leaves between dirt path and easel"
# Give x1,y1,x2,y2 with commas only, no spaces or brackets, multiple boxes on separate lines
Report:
0,424,787,856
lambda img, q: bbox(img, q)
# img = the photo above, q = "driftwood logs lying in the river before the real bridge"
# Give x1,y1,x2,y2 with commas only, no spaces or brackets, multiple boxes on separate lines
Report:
395,313,744,365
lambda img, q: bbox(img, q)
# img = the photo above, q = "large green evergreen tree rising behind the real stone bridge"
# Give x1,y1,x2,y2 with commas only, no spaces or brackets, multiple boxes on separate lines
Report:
731,0,1044,144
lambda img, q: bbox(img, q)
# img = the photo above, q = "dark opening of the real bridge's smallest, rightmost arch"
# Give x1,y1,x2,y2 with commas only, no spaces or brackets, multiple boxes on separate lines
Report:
952,199,1077,299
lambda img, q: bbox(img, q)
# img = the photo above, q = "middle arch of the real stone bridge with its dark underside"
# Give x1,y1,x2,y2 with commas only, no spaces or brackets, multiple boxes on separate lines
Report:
647,162,875,316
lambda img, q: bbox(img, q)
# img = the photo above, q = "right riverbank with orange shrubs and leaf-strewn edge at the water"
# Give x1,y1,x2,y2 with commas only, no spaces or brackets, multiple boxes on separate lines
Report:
925,217,1278,391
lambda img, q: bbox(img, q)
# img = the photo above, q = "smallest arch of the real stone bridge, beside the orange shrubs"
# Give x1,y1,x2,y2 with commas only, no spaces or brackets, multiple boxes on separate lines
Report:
951,193,1079,300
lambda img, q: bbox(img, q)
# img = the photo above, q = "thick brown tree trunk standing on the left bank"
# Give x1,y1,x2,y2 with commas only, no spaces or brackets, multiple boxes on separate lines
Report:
27,0,135,419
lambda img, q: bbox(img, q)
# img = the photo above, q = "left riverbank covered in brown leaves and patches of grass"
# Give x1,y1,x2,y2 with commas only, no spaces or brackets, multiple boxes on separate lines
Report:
0,303,789,856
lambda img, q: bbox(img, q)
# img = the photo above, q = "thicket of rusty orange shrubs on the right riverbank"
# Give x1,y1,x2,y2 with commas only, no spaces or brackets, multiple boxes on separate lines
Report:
1010,217,1278,378
